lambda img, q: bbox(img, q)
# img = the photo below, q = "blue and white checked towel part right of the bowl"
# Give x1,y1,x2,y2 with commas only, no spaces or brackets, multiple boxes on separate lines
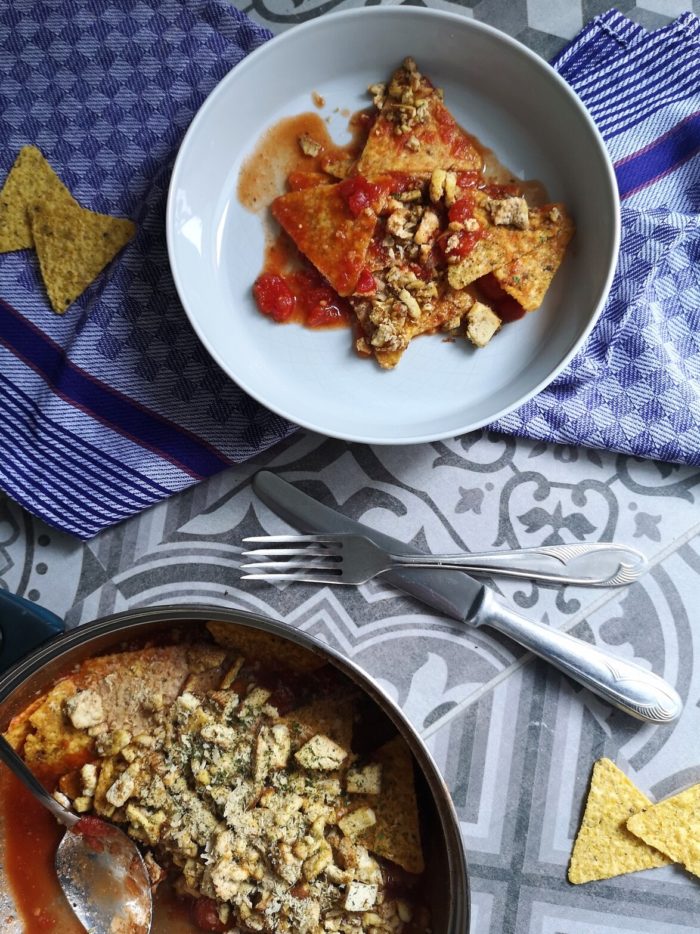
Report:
491,10,700,466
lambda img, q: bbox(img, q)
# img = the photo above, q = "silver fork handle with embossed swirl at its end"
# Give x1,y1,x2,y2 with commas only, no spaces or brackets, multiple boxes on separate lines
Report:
390,542,646,587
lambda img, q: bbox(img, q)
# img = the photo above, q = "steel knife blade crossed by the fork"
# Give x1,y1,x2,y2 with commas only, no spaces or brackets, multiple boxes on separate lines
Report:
253,470,484,622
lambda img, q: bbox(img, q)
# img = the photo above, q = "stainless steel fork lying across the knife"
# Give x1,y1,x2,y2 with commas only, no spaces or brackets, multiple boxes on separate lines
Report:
241,532,647,587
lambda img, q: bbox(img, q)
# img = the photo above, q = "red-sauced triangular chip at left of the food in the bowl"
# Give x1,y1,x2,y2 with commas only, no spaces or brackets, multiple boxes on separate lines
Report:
272,176,386,296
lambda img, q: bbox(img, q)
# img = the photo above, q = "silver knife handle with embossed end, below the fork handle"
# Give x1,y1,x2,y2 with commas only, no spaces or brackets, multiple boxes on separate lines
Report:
478,591,683,723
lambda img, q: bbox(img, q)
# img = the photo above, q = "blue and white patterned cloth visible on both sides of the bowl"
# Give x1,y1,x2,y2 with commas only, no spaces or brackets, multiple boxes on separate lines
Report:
0,0,700,538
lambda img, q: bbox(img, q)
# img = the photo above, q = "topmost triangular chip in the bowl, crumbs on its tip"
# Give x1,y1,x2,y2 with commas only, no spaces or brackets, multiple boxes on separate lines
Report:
357,59,483,176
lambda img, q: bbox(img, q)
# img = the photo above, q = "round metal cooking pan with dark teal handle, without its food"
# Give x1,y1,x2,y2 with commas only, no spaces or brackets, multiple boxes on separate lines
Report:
0,591,469,934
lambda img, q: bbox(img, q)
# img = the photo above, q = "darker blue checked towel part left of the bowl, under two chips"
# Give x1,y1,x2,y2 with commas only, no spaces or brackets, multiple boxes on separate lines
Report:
0,0,295,538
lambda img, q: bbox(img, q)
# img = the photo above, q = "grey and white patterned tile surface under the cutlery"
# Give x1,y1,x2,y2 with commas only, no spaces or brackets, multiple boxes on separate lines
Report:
0,0,700,934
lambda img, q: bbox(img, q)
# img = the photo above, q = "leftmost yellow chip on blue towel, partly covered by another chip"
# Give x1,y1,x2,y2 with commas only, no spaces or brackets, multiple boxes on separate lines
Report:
0,146,79,253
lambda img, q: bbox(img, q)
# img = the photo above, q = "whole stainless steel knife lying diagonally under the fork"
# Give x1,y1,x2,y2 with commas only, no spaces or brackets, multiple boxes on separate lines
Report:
253,470,683,723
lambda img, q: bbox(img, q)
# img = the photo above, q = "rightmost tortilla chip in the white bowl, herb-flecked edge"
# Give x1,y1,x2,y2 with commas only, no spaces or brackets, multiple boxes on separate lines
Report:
493,204,574,311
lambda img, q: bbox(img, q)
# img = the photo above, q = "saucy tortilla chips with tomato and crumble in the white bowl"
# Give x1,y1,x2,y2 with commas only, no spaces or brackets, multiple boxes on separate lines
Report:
253,58,574,369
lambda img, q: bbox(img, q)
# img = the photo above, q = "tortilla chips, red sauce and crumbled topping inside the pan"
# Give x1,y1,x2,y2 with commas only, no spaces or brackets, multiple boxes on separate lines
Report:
1,622,430,934
